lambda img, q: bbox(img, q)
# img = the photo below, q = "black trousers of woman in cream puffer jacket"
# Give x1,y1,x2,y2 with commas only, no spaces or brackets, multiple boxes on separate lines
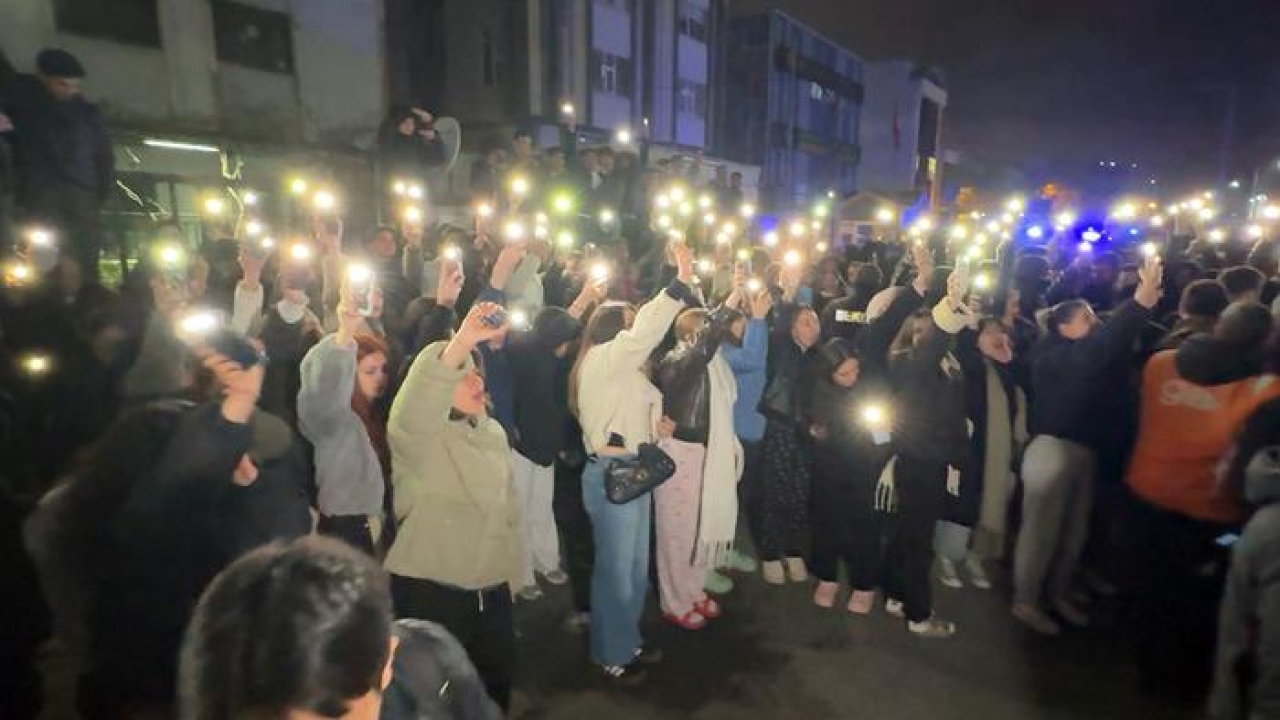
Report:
392,575,516,710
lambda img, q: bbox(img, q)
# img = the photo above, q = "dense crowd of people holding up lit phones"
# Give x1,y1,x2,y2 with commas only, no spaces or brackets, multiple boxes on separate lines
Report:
0,49,1280,719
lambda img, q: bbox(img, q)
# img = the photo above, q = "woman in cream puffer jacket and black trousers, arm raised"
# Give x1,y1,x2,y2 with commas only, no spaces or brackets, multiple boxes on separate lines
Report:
385,302,525,708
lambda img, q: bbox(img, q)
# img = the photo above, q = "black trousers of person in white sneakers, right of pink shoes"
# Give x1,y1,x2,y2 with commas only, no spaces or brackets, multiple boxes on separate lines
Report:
884,455,947,623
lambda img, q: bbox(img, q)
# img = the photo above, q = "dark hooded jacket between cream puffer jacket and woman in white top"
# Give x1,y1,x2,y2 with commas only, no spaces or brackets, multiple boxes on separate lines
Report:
508,307,582,468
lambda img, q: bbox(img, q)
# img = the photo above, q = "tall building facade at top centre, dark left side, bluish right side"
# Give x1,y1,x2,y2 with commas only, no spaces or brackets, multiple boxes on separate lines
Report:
387,0,724,149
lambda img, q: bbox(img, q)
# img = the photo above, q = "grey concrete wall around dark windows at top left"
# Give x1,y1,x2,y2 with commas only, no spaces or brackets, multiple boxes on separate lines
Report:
0,0,384,145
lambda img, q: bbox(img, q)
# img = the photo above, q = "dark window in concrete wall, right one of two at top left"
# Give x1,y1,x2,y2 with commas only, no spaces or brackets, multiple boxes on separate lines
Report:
214,0,293,74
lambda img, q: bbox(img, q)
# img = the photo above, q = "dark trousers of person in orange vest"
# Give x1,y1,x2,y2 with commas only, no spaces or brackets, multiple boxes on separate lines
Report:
1121,498,1238,702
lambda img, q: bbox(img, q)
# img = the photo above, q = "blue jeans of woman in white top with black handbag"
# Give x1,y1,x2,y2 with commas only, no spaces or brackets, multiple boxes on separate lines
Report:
582,457,653,665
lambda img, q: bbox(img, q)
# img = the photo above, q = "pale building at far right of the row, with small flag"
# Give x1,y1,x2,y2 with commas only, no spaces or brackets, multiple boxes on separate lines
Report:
860,60,947,202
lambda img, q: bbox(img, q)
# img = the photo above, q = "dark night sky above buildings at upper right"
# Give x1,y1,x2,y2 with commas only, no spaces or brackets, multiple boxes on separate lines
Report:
778,0,1280,187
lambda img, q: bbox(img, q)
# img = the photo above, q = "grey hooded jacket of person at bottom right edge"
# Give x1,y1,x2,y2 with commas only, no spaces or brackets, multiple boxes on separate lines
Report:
1210,446,1280,720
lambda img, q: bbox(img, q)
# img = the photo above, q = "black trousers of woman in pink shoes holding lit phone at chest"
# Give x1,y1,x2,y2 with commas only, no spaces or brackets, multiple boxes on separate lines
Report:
809,445,882,591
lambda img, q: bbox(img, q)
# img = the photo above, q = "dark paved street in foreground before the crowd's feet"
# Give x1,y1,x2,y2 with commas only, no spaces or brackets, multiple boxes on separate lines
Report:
517,563,1196,720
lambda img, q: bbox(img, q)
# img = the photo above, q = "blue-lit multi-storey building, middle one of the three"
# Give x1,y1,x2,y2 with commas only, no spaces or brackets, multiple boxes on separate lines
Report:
718,10,864,210
